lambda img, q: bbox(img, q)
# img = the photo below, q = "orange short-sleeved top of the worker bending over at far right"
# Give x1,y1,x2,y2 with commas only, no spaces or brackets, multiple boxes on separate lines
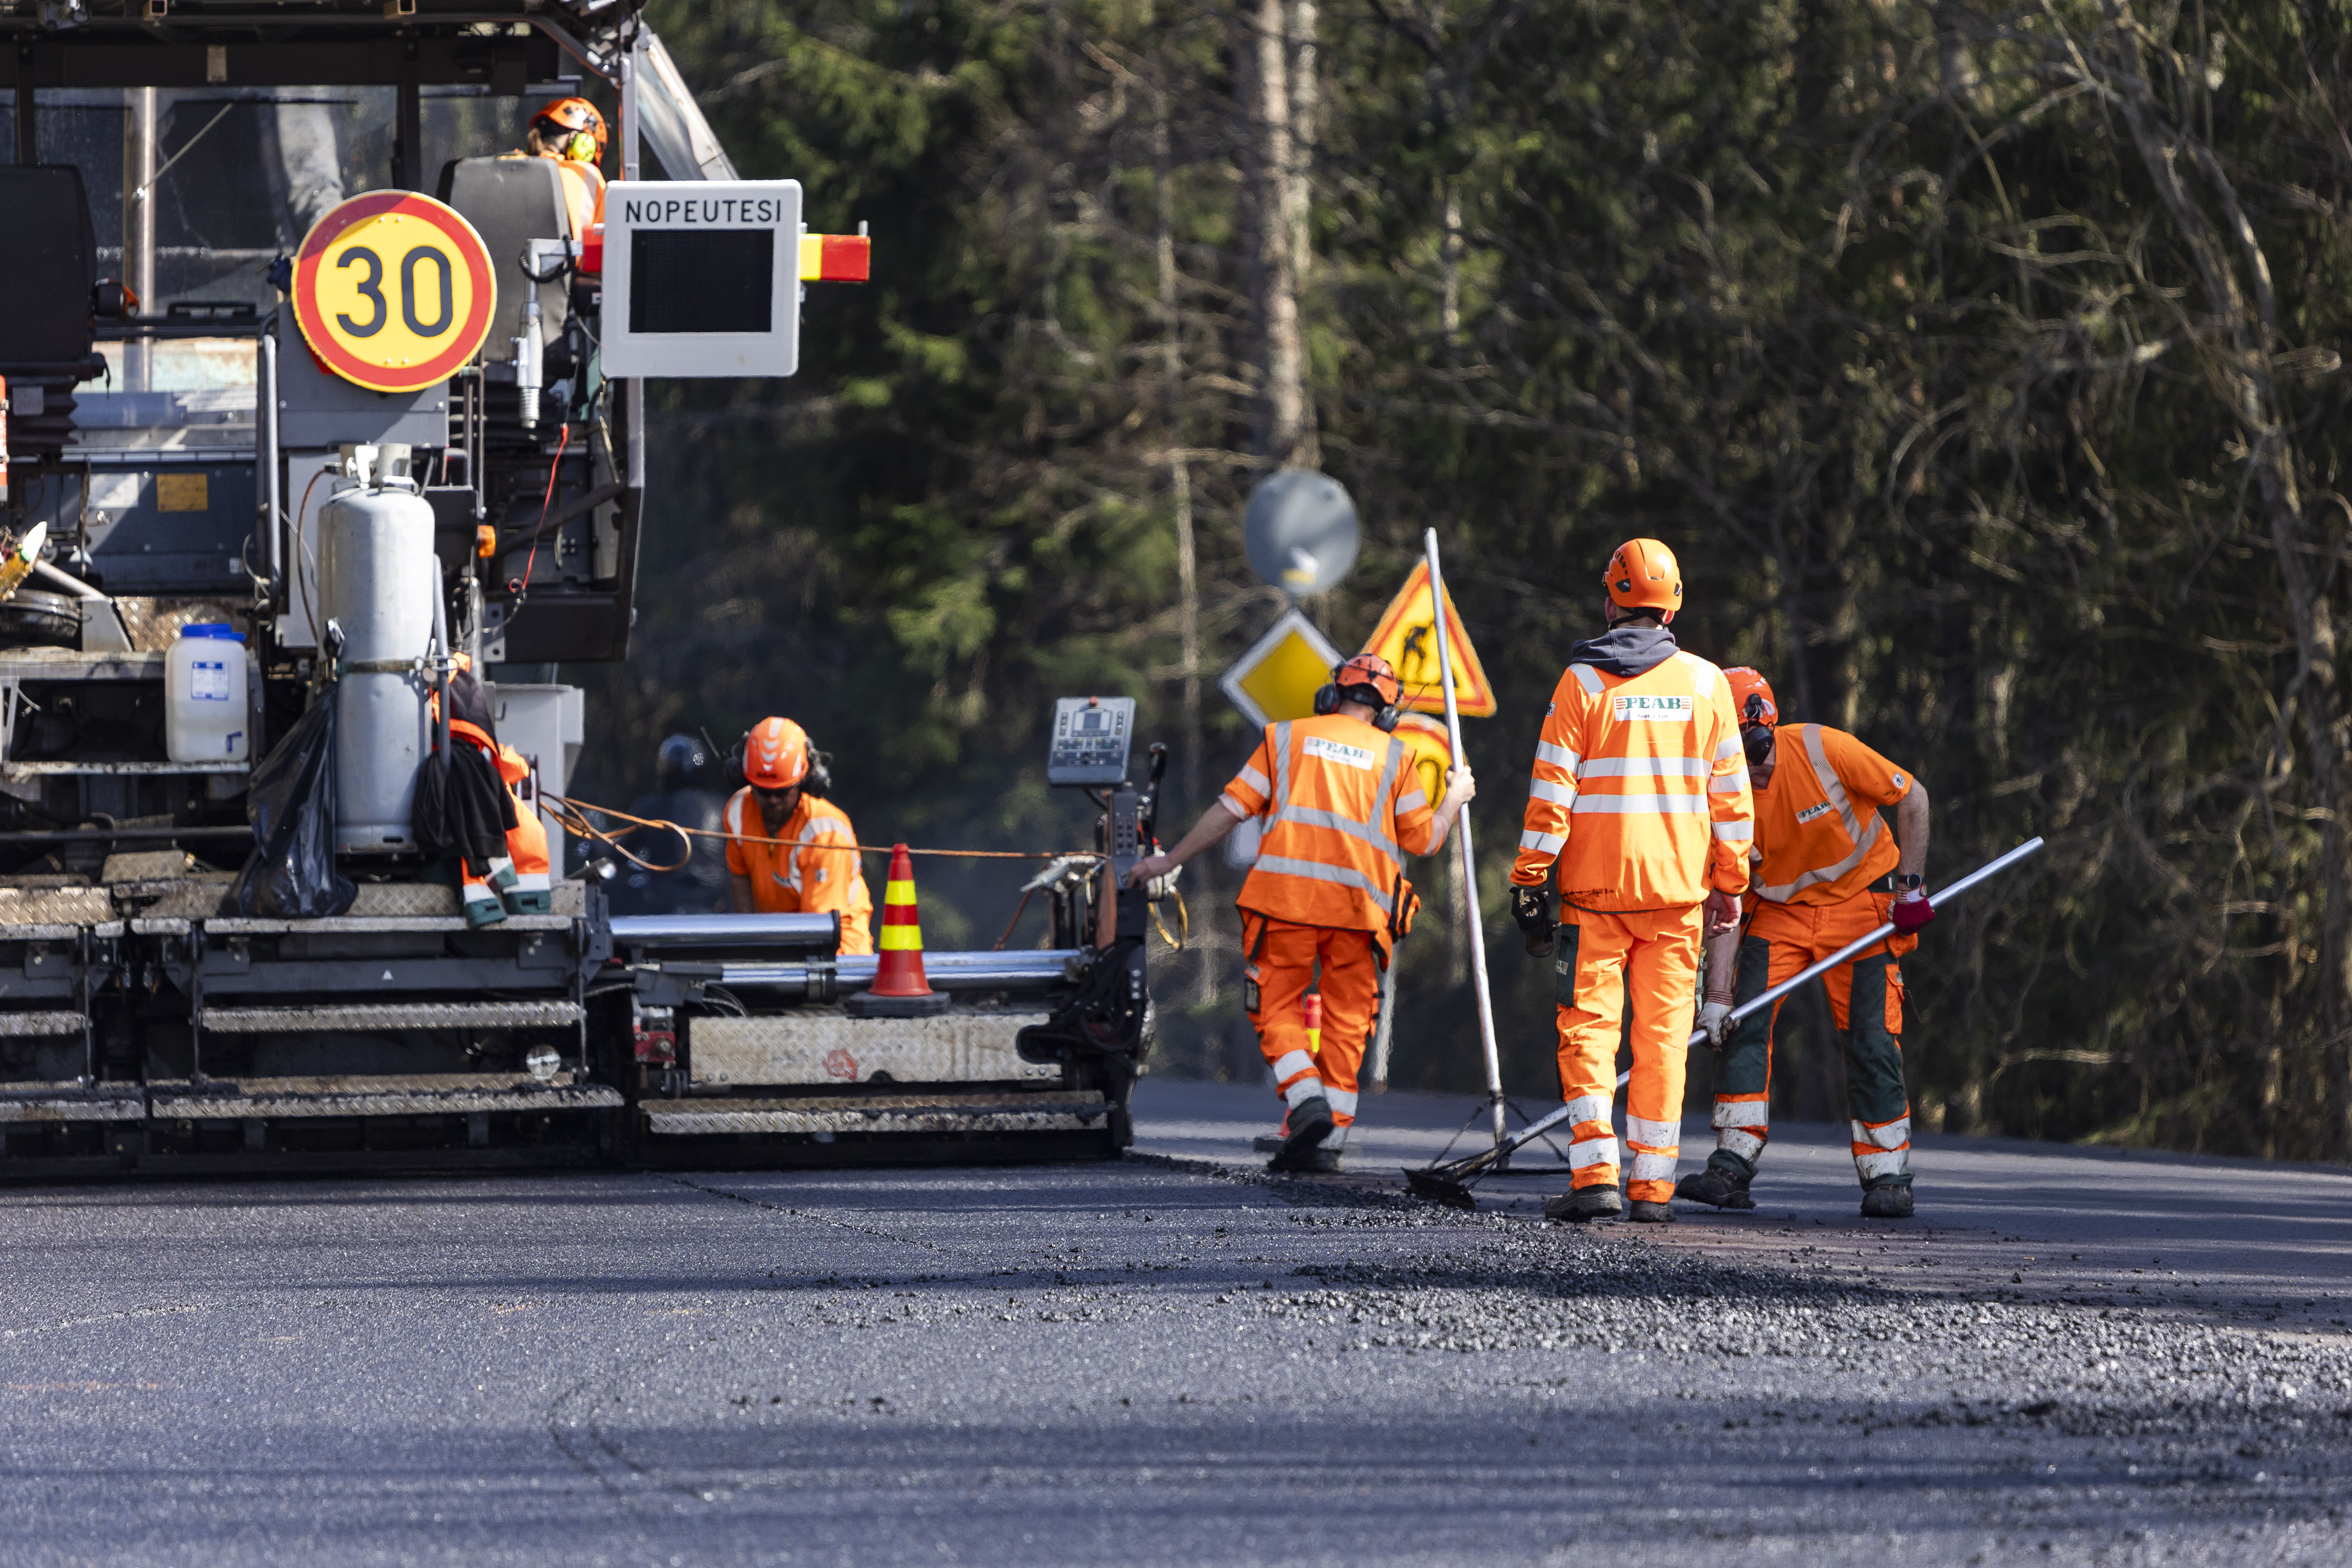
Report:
1750,724,1912,903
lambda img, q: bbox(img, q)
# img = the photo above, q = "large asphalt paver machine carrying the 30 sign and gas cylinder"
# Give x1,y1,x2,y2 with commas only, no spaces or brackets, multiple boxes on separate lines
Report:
0,0,1157,1180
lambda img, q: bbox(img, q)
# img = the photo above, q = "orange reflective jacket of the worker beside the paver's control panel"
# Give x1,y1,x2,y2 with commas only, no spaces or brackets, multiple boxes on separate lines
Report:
1223,712,1437,931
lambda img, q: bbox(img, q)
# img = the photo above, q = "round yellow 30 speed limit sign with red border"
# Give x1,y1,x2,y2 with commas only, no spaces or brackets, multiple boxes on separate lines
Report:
294,190,499,393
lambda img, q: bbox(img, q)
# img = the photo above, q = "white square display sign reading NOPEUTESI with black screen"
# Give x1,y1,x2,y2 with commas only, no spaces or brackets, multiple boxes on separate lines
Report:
604,179,800,376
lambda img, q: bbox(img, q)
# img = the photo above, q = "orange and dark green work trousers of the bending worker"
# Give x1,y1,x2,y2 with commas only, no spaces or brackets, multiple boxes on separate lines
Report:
1708,889,1919,1187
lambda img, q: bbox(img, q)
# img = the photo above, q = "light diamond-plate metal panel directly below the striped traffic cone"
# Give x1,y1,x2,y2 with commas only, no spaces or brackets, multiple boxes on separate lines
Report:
687,1009,1061,1086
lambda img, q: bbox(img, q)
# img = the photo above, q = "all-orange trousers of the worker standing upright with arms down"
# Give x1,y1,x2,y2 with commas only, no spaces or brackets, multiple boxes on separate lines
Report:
1557,905,1705,1204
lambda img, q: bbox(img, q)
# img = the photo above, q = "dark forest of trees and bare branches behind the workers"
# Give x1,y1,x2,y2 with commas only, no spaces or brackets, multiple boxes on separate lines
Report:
572,0,2352,1159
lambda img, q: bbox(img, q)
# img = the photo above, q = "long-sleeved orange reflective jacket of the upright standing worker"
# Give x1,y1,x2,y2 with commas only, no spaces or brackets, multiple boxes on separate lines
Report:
1510,653,1755,912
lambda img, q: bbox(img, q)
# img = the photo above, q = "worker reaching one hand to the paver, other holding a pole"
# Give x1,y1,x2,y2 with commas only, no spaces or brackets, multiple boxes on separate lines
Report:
1127,653,1477,1171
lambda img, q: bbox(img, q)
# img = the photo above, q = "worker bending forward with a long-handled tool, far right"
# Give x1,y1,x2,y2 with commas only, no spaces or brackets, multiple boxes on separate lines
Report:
1675,667,1936,1220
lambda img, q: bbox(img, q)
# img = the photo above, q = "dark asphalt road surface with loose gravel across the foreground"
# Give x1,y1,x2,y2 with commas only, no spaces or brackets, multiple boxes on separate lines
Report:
0,1081,2352,1566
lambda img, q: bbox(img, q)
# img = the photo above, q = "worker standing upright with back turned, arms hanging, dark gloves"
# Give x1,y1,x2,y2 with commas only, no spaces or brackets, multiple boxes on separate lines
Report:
1510,538,1752,1222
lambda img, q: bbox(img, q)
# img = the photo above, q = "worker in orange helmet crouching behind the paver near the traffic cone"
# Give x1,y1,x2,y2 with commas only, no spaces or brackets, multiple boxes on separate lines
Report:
722,719,875,955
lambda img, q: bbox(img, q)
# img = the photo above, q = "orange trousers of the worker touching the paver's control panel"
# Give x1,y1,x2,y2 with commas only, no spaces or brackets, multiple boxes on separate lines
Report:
1242,910,1383,1147
